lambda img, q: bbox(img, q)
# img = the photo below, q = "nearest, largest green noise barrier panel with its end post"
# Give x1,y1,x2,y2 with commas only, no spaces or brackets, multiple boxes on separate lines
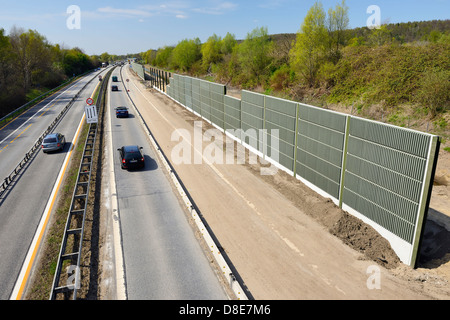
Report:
341,117,439,264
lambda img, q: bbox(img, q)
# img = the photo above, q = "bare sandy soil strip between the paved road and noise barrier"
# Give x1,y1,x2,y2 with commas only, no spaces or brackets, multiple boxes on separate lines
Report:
126,68,450,300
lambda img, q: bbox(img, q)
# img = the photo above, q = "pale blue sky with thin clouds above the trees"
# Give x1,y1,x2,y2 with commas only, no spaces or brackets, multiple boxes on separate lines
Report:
0,0,450,55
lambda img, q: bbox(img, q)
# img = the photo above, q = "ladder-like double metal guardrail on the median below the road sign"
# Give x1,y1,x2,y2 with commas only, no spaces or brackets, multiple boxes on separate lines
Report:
50,70,112,300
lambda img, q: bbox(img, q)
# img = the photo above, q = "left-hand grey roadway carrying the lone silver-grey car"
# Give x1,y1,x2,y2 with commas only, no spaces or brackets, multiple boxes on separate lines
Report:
0,70,103,300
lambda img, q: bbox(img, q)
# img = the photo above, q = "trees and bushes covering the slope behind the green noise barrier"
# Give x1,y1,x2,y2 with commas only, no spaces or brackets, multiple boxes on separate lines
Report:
141,0,450,119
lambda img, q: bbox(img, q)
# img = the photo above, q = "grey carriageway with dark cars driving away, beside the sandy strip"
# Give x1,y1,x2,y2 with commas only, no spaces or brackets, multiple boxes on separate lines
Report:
106,66,228,300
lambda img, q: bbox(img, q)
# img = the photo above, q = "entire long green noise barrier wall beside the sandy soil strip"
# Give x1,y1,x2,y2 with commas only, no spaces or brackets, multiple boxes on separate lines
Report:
163,70,440,267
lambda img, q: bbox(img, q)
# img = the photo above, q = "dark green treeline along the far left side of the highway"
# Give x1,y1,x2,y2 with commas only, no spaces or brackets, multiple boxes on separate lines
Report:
0,27,109,117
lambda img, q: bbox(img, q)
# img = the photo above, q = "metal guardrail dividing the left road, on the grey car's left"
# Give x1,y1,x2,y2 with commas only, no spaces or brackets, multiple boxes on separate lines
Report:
0,70,107,197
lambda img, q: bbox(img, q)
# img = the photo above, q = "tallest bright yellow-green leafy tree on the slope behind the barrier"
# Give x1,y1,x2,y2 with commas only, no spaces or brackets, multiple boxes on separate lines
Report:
290,2,328,87
